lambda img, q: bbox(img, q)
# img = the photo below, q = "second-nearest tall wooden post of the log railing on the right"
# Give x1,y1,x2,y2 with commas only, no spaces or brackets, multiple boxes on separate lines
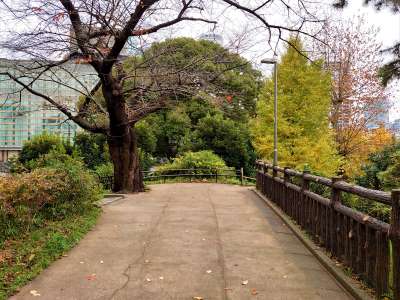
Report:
329,176,342,257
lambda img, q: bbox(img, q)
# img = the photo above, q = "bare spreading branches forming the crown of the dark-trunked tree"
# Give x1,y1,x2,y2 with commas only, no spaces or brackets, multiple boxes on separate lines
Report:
0,0,319,135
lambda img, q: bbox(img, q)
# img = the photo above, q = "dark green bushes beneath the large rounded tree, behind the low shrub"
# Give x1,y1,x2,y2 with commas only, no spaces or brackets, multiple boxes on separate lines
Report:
136,99,255,173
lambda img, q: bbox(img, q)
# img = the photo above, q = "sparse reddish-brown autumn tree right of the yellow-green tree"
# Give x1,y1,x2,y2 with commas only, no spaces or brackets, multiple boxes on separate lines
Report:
314,17,391,177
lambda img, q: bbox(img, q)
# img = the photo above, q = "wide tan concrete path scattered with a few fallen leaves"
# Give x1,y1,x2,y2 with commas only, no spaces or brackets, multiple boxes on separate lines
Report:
12,184,350,300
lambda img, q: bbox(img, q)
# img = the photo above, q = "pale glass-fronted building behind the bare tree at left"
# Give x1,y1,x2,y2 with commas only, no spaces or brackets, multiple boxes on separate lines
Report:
0,60,98,161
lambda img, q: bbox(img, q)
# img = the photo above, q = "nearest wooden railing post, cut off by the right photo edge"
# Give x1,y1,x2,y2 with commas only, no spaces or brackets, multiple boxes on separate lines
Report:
389,189,400,299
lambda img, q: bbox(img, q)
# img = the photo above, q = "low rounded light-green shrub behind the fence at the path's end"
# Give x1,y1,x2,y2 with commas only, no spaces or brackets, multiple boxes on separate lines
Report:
157,150,231,174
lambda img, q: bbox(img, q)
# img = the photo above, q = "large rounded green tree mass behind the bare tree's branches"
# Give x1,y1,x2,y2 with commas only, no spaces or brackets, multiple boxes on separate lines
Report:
125,38,261,176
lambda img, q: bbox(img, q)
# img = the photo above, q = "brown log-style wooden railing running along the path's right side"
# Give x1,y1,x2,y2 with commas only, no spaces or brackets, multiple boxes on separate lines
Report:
256,161,400,300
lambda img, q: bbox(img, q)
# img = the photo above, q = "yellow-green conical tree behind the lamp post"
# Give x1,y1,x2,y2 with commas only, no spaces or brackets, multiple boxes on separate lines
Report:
250,38,340,175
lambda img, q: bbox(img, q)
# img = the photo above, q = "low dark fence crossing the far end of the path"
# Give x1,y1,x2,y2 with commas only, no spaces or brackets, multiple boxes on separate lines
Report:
142,168,256,185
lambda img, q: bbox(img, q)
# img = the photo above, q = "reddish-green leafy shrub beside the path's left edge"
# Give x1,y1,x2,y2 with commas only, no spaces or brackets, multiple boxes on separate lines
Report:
0,151,102,242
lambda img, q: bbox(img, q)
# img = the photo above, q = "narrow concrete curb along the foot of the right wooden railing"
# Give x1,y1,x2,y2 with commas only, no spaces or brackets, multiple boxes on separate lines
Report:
250,188,374,300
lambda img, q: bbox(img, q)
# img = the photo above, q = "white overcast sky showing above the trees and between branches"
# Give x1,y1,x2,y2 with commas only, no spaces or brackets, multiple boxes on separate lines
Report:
0,0,400,120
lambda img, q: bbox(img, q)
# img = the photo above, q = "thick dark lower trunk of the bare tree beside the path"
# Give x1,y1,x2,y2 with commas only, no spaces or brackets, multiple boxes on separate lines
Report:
108,126,144,193
